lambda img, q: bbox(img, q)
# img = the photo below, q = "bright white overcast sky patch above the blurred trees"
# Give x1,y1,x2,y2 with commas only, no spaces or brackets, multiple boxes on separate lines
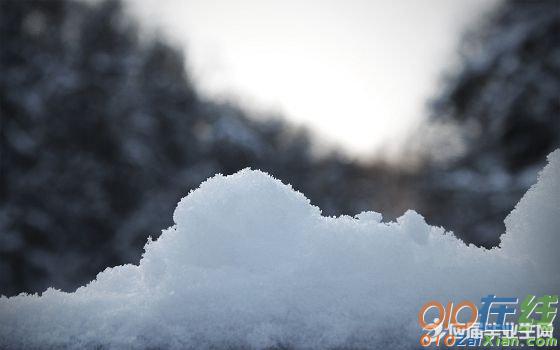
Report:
128,0,496,156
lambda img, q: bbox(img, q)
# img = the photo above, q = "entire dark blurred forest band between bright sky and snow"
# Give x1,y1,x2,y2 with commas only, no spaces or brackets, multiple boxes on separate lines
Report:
0,0,560,295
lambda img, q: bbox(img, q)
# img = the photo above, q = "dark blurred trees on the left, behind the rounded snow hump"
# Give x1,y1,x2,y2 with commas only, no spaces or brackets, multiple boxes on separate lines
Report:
0,0,380,295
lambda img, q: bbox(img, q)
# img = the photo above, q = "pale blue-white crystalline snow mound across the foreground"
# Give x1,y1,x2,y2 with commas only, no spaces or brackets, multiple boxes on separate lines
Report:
0,150,560,349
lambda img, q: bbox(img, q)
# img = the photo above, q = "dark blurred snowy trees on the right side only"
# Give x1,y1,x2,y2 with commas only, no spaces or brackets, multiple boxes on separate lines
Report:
417,0,560,247
